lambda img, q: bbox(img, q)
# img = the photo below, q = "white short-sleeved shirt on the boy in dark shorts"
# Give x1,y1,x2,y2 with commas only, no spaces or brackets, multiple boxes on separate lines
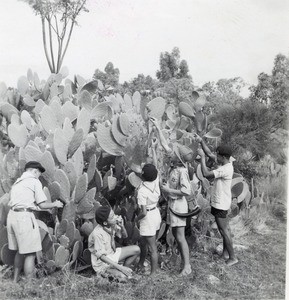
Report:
211,163,234,210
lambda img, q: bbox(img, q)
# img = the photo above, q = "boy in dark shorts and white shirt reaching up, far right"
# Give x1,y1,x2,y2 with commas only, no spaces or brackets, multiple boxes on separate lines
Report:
196,136,238,266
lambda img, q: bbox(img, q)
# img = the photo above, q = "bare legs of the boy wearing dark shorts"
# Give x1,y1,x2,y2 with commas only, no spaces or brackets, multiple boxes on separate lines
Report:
216,217,238,266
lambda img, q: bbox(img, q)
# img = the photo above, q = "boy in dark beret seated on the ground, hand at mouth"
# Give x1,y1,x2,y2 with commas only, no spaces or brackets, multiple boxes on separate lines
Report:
88,206,140,278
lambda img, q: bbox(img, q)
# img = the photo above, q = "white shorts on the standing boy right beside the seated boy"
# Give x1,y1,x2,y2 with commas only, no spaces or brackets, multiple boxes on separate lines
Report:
139,207,162,236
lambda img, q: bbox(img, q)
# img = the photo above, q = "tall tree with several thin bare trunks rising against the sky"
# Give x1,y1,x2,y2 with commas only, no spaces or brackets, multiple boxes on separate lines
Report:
21,0,88,73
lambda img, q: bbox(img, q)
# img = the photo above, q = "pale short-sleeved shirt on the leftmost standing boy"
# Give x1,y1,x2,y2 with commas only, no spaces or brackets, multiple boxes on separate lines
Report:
8,172,47,209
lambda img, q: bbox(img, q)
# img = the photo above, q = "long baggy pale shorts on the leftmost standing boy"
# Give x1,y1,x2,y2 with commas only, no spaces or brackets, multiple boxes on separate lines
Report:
7,210,42,254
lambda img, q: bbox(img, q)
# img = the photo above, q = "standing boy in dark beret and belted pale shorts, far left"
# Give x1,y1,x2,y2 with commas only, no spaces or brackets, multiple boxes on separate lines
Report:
7,161,63,282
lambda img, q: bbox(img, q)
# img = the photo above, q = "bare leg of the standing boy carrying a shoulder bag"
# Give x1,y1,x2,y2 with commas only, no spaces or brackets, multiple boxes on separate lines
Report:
172,226,192,275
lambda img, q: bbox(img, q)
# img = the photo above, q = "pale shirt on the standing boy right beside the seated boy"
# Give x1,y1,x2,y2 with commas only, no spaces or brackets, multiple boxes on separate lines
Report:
137,177,161,209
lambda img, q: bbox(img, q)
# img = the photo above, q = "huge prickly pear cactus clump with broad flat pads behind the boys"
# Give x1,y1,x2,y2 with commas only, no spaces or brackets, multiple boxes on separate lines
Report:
0,68,258,270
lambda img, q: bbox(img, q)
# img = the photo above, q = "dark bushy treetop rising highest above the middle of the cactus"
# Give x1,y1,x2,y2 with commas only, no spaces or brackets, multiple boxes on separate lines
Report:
156,47,191,82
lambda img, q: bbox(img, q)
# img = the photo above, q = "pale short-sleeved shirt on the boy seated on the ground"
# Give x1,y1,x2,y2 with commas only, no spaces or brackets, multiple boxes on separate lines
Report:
88,224,115,273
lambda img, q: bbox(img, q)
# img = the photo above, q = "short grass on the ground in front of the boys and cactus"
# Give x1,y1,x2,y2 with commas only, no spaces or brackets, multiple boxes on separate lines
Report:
0,217,286,300
